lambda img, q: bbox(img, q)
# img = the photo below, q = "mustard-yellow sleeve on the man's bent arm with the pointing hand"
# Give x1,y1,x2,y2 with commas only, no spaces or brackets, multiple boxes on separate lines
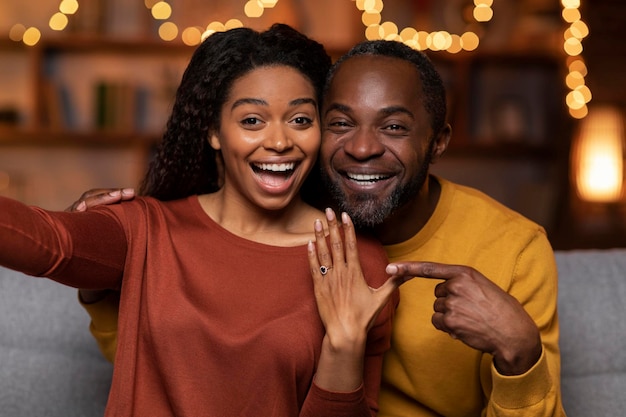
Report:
482,231,565,417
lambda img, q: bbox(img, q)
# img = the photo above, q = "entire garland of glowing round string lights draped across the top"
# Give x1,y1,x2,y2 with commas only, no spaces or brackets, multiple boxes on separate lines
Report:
9,0,592,119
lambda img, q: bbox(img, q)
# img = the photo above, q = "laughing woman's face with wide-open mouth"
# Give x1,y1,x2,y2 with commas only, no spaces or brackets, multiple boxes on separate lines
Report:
209,66,321,210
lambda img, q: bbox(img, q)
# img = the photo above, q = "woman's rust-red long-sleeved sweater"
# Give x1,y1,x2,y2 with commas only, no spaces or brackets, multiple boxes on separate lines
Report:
0,196,397,417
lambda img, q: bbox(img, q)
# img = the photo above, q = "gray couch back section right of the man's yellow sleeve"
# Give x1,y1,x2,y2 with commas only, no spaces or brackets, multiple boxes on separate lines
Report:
556,249,626,417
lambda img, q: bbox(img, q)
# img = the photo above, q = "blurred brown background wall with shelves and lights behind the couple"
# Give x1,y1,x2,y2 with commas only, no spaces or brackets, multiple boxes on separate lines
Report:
0,0,626,249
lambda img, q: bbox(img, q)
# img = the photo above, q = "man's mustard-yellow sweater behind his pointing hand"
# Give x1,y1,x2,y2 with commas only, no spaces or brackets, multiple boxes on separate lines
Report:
379,178,565,417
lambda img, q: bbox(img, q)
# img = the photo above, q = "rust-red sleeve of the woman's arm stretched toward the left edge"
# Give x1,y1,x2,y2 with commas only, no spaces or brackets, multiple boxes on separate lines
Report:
0,197,127,289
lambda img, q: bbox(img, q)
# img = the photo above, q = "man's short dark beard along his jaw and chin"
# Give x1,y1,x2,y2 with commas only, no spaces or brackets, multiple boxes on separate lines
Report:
321,152,431,229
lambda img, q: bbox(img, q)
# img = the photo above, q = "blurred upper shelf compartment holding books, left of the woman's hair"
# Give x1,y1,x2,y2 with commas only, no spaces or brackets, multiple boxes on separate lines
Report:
0,35,193,145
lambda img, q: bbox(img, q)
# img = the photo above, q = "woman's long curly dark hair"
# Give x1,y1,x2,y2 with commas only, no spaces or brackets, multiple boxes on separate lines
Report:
140,24,331,200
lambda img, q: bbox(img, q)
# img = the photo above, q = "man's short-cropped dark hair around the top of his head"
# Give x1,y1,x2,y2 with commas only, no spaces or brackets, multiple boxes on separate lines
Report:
324,40,446,136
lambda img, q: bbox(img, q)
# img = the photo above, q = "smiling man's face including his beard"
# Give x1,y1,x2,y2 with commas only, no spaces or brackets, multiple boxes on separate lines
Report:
320,55,433,227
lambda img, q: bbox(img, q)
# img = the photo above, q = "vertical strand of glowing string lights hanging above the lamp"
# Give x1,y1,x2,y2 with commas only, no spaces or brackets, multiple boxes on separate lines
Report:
561,0,592,119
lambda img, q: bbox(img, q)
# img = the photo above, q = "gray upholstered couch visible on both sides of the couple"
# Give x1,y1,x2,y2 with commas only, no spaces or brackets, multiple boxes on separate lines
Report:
0,249,626,417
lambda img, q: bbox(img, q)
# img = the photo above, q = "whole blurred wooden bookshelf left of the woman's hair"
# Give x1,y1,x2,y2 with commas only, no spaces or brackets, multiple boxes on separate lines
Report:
0,33,193,210
